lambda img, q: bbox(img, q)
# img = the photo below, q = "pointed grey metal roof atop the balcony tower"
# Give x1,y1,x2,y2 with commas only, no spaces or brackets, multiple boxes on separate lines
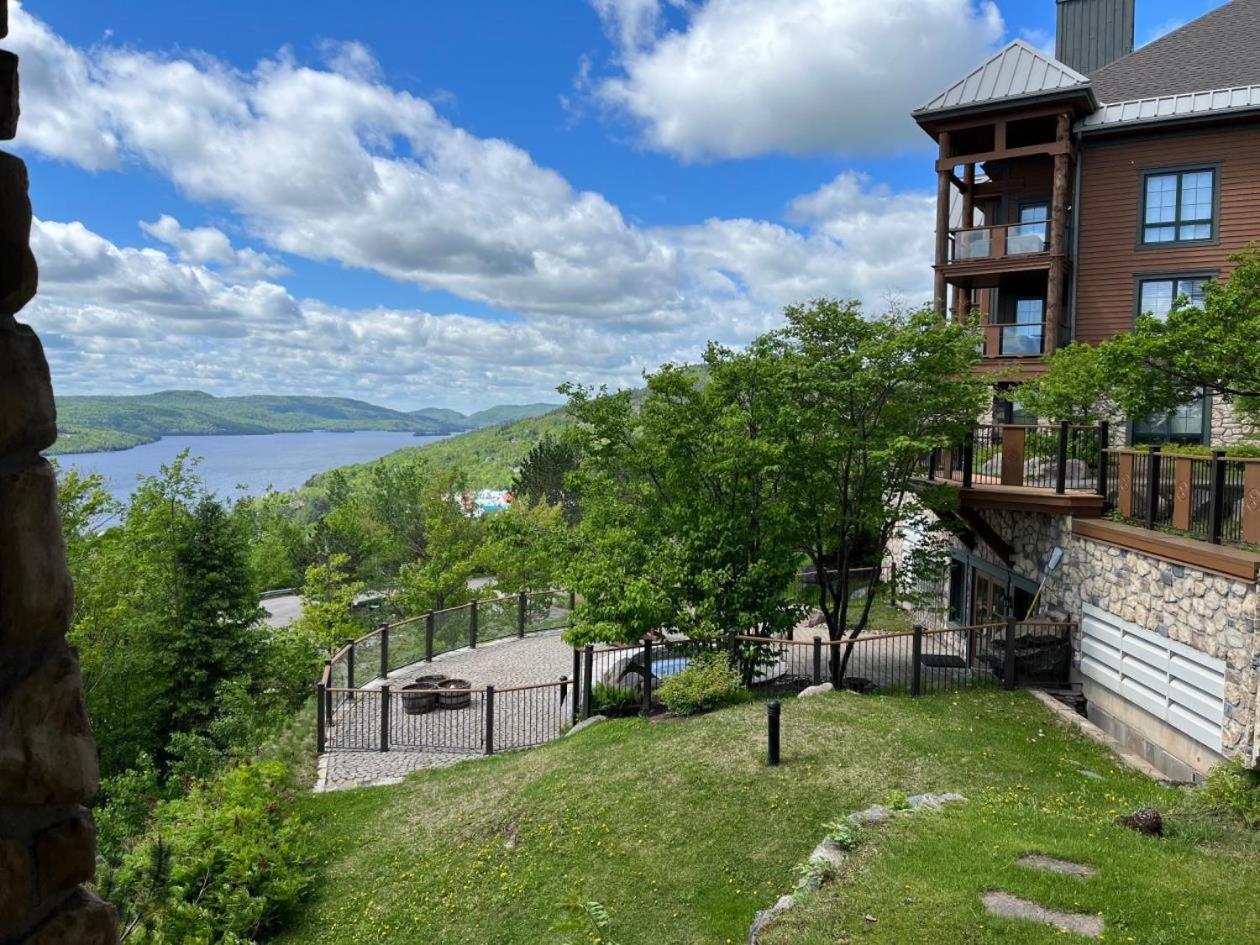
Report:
914,39,1090,117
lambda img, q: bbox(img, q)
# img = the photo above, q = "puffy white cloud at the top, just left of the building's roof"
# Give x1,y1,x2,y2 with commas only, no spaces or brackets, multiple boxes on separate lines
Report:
592,0,1004,160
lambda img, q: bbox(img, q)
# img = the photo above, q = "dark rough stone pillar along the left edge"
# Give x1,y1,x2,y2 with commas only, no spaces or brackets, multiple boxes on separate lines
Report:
0,0,117,945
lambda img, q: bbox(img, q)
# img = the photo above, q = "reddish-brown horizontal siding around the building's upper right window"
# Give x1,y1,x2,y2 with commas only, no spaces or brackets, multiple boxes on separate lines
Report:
1075,123,1260,343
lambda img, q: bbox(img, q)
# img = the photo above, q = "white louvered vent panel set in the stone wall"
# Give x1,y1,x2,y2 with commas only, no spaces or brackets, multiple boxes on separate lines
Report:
1081,605,1225,751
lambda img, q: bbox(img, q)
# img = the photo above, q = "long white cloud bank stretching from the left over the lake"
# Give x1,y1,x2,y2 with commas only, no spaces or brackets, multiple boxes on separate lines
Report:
11,0,932,406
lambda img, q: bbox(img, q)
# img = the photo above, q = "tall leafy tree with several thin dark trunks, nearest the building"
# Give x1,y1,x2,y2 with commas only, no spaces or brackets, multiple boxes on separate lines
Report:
751,300,987,683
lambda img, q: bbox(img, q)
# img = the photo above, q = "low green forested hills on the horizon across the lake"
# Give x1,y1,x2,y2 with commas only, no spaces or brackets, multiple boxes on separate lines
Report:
49,391,556,454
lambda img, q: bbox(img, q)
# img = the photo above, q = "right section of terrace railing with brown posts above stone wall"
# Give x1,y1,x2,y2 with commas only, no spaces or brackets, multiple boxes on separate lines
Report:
1105,446,1260,546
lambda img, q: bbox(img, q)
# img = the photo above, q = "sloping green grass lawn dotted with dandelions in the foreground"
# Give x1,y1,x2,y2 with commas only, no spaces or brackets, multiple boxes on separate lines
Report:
284,692,1260,945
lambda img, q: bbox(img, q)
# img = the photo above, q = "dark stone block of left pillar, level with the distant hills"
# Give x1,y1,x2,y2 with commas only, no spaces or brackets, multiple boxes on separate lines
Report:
0,324,57,456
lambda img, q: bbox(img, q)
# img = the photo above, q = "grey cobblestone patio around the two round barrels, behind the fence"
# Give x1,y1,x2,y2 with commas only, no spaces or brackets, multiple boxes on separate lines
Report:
315,630,573,791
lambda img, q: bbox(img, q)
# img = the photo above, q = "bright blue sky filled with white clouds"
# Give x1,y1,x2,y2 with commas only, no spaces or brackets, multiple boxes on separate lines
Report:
0,0,1217,411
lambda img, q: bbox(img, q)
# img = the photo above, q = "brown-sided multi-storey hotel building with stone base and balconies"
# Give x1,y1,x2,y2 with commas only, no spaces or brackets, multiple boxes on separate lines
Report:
914,0,1260,777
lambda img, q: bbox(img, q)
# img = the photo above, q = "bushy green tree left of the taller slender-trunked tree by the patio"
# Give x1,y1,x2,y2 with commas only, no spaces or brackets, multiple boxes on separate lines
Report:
562,345,799,660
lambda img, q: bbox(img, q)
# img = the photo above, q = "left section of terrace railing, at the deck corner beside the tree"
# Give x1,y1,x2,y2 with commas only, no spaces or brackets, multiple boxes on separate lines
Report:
926,423,1108,495
